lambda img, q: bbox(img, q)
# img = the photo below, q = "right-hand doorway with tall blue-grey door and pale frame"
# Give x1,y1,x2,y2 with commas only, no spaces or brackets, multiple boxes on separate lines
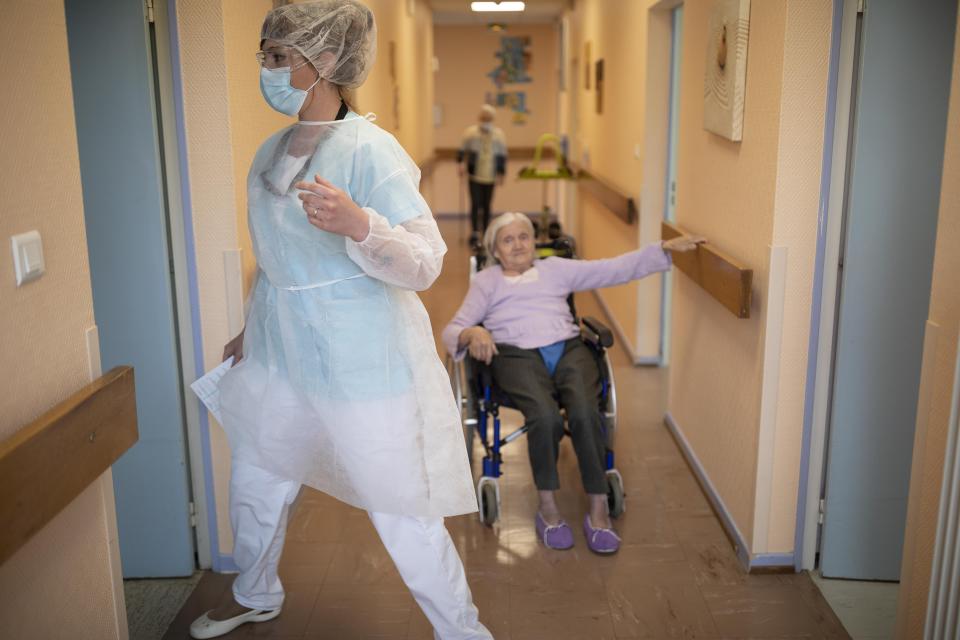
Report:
801,0,957,636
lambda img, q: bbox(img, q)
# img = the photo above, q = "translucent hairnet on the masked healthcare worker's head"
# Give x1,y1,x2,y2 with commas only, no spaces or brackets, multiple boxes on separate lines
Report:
260,0,377,89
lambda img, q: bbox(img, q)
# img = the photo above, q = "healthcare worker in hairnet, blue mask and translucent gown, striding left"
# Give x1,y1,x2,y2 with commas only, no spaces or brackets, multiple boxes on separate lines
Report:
190,0,492,639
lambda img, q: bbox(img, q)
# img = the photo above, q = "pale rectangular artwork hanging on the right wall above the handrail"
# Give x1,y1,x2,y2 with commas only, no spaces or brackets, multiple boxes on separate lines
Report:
703,0,750,142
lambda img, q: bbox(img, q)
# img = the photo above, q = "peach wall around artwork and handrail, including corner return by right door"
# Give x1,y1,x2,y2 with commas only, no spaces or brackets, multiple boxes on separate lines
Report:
668,0,831,553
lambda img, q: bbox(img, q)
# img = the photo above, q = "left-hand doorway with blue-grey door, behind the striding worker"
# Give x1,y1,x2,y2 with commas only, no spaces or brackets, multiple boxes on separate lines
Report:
65,0,197,578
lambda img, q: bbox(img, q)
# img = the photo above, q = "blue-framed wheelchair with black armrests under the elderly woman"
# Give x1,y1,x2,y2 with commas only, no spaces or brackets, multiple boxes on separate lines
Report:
447,230,626,526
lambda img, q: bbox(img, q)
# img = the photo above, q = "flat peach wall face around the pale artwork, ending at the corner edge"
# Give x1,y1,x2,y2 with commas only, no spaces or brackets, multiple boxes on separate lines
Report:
669,2,795,543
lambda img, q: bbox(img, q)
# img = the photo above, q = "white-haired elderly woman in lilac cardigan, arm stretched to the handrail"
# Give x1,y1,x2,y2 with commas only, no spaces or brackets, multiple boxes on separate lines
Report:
443,213,702,553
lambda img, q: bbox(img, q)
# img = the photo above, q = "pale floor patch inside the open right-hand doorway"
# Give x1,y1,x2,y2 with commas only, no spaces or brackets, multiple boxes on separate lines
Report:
811,573,900,640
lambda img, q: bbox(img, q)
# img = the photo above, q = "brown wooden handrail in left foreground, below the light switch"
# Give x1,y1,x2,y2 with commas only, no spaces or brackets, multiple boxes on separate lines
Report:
0,367,138,564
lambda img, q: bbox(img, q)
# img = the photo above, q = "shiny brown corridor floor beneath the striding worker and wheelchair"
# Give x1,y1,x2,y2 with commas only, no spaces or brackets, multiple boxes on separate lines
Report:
165,221,849,640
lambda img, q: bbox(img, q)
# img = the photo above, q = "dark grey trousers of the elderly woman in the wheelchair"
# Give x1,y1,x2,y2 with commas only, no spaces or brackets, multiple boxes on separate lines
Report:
492,337,607,494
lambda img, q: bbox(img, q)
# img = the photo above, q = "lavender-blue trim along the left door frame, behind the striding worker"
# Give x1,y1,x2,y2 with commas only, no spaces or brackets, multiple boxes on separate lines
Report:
167,0,224,572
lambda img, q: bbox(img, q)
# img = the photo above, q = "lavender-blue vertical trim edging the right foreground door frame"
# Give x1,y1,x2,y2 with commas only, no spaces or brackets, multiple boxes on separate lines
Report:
793,0,843,571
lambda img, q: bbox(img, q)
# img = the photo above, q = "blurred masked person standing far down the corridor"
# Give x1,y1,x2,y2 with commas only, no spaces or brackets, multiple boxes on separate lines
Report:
457,104,507,245
